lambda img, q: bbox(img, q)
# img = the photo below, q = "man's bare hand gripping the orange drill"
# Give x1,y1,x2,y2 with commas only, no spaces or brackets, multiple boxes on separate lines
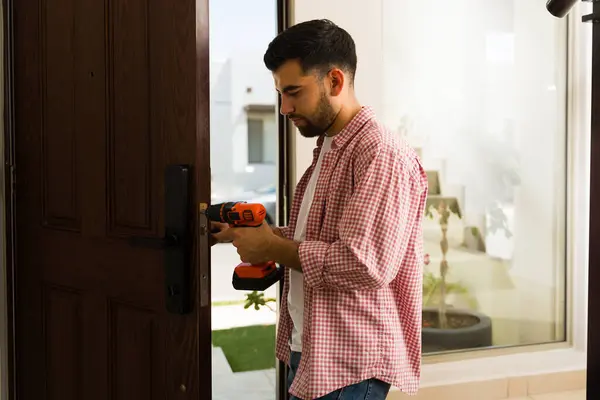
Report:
213,222,277,264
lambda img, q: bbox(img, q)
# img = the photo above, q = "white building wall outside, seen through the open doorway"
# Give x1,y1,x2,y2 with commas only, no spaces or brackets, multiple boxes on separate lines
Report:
210,54,277,196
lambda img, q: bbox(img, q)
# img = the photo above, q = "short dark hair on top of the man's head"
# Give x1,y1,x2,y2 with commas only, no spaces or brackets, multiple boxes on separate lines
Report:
264,19,356,82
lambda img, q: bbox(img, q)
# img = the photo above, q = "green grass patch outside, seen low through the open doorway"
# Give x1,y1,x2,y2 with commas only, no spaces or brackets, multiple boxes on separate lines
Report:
212,325,275,372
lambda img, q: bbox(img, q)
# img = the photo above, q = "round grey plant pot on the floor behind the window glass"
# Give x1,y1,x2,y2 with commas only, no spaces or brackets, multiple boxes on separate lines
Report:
422,307,492,353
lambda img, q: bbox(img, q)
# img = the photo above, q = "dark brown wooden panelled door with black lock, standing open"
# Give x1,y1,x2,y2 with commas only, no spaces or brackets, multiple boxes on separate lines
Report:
12,0,211,400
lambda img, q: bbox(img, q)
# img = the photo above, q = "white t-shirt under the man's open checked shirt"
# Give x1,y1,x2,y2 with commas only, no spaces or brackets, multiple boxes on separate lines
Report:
288,136,333,352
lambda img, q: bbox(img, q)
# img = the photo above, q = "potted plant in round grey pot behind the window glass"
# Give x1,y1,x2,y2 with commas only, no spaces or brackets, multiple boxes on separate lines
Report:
422,196,492,352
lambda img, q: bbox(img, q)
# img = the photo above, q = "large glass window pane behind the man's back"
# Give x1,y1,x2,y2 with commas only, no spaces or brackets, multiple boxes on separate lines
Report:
380,0,567,353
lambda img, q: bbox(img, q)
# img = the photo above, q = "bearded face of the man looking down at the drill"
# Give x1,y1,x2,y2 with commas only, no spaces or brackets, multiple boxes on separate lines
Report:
273,60,337,138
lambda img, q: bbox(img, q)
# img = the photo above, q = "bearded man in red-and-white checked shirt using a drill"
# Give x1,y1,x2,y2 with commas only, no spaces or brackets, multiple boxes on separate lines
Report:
214,20,427,400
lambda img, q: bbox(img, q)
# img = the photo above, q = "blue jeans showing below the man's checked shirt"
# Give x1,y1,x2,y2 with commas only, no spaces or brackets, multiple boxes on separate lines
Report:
287,351,391,400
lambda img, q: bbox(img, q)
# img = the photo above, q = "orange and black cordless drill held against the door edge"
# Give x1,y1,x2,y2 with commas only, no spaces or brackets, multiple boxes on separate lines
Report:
205,201,281,291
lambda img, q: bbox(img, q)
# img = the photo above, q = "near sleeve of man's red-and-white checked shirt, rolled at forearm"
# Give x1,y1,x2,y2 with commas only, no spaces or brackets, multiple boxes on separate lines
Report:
298,143,427,290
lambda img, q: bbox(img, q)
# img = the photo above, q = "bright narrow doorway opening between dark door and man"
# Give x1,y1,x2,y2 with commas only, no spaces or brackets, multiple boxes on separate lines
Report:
209,0,278,400
